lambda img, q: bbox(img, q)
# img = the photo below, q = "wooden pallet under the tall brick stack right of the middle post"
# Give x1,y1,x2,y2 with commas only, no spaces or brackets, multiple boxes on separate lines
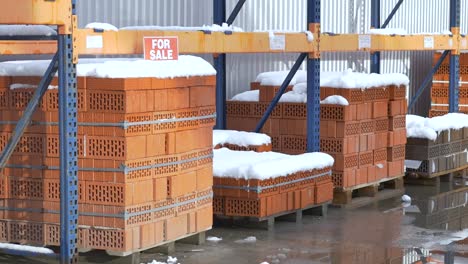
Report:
332,175,405,209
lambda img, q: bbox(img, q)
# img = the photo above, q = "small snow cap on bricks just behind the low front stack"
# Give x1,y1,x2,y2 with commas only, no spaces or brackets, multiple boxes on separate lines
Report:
213,130,271,147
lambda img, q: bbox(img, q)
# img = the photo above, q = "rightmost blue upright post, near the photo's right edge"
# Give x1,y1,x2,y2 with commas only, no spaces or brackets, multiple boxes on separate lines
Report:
449,0,460,113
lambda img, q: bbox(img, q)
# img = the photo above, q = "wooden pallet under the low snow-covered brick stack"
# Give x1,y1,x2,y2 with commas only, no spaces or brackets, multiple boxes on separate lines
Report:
214,202,331,230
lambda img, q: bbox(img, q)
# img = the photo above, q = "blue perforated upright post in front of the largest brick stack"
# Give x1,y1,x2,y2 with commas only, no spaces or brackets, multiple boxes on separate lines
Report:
58,0,78,264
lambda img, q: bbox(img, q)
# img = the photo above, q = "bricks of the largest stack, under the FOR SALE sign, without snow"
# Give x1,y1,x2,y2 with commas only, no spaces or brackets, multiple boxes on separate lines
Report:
0,76,216,252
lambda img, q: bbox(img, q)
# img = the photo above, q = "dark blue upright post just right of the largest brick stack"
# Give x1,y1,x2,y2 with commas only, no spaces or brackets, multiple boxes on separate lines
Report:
213,0,226,129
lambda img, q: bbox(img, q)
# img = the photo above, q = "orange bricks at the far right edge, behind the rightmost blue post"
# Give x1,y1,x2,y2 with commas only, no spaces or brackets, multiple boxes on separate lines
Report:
429,53,468,117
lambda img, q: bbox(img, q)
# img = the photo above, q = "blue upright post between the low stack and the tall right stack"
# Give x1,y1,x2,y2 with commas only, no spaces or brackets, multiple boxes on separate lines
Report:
307,0,321,152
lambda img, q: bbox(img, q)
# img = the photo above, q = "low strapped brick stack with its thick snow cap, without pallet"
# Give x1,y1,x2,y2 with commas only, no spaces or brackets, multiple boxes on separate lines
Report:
213,148,334,218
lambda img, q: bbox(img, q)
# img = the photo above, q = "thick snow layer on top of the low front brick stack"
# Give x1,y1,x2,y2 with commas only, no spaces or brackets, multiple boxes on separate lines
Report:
213,148,334,180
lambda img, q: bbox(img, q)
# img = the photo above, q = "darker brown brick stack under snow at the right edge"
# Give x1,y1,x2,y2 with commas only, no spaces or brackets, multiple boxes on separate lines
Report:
406,127,468,177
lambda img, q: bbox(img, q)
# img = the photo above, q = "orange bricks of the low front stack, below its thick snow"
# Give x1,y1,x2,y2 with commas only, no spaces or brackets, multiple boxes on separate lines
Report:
213,150,333,219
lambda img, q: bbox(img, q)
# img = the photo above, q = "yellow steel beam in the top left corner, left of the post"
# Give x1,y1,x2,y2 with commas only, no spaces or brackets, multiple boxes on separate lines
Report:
0,0,72,26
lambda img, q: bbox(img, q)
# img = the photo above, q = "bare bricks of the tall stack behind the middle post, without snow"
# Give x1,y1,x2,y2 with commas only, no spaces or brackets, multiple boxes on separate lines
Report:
227,82,407,188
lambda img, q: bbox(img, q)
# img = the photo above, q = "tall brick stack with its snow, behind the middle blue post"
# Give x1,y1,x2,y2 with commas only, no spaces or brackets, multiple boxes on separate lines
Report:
227,70,409,191
